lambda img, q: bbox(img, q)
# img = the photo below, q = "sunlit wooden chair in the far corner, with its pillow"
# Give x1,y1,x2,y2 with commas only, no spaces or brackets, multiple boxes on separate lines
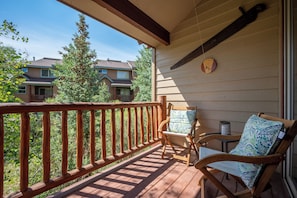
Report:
158,103,199,166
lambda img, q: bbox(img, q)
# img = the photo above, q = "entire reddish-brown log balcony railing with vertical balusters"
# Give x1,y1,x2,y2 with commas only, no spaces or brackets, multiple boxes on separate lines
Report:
0,97,166,197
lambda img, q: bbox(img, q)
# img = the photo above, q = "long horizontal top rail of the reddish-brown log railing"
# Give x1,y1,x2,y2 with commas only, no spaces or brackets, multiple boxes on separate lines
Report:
0,102,161,114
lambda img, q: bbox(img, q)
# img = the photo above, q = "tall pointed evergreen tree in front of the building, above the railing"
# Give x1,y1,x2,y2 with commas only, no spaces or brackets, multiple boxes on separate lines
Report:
53,14,110,102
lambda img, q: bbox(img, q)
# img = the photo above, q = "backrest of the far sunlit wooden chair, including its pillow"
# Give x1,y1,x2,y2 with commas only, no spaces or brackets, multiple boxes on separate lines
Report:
167,103,198,134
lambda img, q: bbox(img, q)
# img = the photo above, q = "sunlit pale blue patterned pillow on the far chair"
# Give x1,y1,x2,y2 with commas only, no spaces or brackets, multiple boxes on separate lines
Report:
168,110,196,134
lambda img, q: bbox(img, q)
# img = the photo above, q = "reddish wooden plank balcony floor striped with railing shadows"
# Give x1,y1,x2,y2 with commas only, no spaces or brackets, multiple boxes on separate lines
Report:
51,146,289,198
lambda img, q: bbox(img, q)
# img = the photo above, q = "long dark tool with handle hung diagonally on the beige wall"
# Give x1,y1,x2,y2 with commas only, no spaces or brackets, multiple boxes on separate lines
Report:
170,4,266,70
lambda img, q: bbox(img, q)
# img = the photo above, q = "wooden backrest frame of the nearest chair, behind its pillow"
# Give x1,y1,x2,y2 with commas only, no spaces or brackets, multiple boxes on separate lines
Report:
254,113,297,195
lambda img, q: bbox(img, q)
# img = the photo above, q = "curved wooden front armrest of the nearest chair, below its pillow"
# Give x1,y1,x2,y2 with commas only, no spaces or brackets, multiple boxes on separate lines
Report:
194,153,284,169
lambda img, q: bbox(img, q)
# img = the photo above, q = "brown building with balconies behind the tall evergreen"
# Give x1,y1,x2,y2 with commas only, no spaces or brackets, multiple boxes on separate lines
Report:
16,58,135,102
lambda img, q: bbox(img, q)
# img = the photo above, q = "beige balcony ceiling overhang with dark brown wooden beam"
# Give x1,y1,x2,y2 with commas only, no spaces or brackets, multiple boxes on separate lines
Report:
58,0,200,47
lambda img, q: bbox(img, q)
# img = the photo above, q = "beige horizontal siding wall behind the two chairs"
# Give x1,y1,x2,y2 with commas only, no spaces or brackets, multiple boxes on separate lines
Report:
156,0,282,135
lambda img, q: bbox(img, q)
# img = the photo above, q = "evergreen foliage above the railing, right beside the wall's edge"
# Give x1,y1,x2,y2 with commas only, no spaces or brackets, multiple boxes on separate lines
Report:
132,47,152,101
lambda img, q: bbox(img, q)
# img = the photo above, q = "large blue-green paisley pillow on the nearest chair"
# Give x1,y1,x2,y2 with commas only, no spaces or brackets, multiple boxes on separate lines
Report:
230,115,283,188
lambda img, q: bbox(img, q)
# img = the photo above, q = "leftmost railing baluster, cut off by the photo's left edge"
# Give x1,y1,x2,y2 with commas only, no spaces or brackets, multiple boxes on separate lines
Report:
0,114,4,197
